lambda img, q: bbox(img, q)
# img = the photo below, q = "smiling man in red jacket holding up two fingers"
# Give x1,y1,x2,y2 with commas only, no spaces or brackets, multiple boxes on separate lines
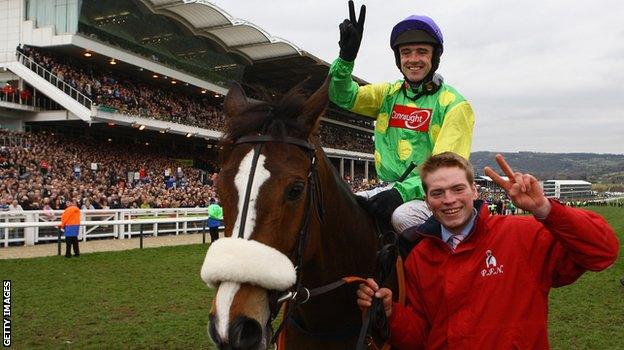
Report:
357,152,618,349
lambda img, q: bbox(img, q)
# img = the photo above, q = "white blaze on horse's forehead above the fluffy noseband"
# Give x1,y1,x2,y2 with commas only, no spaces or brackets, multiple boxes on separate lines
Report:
232,150,271,239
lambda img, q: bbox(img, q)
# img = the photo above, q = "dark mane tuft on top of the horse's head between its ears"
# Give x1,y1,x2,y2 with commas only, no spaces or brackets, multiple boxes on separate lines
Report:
224,84,316,144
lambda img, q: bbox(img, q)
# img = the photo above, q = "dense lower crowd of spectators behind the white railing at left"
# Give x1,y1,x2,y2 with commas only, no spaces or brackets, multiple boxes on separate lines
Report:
0,130,216,210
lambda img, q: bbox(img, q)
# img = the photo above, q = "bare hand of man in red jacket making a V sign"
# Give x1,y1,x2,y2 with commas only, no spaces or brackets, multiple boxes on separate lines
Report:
484,154,551,219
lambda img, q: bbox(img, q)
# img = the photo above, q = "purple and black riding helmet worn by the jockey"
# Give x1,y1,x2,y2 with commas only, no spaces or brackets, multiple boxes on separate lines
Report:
390,15,444,81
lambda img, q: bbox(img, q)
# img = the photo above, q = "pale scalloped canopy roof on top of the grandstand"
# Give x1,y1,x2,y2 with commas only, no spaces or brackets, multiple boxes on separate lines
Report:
133,0,365,91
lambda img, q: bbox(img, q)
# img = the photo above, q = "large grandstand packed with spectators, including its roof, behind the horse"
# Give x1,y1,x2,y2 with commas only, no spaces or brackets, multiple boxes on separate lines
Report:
0,0,374,209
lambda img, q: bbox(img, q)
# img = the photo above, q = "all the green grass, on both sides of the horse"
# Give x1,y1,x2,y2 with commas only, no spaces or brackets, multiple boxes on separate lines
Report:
0,207,624,349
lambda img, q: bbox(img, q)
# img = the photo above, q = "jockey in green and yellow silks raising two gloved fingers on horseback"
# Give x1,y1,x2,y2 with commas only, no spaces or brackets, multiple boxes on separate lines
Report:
329,1,474,234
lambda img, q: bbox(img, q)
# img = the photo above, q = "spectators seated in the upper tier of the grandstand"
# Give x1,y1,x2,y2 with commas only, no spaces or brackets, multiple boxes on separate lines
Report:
20,46,373,153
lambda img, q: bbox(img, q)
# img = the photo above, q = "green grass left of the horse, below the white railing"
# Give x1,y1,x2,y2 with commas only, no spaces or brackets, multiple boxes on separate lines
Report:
0,245,213,349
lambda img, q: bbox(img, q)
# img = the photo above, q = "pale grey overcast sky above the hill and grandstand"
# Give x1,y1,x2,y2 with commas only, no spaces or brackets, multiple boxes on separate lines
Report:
211,0,624,154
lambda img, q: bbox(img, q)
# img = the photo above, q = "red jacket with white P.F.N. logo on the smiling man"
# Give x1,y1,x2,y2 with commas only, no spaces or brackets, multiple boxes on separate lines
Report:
390,201,618,349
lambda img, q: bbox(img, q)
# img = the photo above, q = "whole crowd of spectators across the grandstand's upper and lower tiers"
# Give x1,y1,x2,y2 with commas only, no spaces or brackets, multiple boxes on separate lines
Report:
6,46,390,210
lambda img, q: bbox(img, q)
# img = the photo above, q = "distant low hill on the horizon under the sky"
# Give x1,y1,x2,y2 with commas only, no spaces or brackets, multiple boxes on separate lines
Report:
470,152,624,184
